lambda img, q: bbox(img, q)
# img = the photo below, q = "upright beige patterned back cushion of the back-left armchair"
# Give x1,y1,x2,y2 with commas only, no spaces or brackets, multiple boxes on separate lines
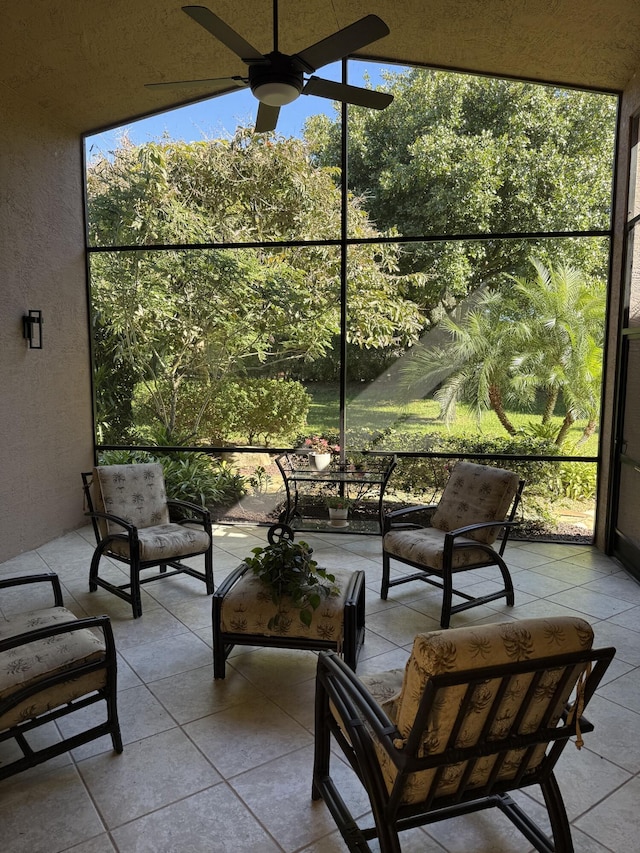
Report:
93,462,169,536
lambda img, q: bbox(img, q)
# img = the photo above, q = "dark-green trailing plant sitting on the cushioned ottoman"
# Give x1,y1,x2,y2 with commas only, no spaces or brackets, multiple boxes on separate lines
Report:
245,539,340,630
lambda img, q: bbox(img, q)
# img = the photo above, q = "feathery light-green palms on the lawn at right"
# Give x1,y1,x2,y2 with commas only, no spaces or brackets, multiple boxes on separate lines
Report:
404,259,605,445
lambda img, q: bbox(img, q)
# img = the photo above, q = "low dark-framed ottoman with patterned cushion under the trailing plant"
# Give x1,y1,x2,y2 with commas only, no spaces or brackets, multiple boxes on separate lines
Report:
212,563,364,678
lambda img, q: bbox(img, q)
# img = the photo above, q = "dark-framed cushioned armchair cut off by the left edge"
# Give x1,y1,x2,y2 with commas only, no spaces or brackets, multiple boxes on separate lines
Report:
0,574,122,779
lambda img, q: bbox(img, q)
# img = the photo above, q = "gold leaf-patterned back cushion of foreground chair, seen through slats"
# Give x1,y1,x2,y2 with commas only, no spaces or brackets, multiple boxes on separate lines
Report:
362,617,593,803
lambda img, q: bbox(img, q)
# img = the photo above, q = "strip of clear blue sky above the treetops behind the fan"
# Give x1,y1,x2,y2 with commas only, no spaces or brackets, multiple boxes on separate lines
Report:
86,62,401,160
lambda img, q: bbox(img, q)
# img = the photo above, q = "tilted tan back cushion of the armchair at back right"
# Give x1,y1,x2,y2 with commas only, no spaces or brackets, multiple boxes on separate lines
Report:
431,462,520,544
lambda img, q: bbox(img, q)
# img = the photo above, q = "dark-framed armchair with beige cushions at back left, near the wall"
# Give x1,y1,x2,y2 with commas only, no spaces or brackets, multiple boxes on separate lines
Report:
82,463,213,617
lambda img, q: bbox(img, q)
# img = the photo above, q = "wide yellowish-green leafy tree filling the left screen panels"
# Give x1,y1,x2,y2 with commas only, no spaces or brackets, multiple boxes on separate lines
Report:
88,135,421,440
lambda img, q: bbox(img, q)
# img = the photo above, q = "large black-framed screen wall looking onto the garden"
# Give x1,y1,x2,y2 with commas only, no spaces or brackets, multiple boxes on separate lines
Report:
87,62,617,541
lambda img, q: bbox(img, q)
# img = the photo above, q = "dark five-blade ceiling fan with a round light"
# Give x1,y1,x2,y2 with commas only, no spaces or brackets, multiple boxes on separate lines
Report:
146,0,393,133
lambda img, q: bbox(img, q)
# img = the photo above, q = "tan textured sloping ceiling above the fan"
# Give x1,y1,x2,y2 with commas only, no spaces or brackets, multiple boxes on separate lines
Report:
0,0,640,132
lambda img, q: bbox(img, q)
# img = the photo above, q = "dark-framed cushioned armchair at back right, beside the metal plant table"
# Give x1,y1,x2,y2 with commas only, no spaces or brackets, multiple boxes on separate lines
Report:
380,462,524,628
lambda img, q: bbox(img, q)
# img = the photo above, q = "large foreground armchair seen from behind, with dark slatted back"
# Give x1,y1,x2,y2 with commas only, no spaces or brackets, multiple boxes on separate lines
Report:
312,617,615,853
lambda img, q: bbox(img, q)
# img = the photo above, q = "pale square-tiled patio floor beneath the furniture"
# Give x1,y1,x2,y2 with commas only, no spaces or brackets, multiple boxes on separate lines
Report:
0,527,640,853
